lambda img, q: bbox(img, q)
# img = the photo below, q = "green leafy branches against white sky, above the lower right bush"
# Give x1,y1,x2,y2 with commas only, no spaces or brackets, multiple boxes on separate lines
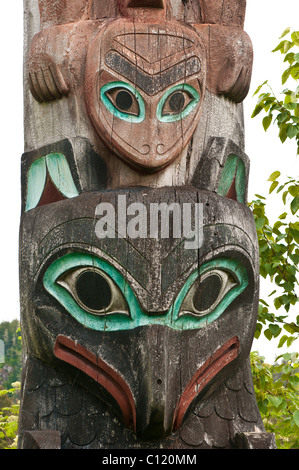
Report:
249,28,299,347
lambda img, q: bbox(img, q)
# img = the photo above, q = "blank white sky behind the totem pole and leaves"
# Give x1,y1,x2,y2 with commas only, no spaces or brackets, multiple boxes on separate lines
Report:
0,0,299,361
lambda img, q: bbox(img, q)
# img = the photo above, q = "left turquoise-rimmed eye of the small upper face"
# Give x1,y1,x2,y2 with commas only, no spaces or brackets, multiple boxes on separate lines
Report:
101,82,145,123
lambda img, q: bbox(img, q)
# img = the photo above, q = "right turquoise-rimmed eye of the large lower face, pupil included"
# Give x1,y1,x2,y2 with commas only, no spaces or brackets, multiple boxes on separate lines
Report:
174,258,248,328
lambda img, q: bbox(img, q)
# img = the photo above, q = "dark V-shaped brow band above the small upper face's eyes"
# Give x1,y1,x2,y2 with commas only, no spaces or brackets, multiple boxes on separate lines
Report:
105,52,200,96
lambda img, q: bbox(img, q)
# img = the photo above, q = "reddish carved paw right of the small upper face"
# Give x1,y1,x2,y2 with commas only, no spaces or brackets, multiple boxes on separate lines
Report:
196,0,253,103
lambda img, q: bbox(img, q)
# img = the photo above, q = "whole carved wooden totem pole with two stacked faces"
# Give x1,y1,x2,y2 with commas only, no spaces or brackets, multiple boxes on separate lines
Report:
19,0,275,449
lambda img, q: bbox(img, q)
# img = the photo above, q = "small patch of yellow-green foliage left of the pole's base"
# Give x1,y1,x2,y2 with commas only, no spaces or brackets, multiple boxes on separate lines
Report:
0,382,20,449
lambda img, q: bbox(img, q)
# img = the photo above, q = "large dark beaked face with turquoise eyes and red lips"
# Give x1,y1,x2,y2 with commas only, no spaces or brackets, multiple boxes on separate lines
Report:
21,188,258,439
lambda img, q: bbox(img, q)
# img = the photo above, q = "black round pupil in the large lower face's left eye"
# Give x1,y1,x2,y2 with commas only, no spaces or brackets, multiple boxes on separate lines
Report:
76,271,112,310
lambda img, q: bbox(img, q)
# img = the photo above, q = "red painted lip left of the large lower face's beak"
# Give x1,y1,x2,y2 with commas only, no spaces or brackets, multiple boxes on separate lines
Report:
54,335,136,431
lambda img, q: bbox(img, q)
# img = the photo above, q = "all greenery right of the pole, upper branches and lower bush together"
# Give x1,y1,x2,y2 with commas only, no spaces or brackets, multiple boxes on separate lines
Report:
249,28,299,449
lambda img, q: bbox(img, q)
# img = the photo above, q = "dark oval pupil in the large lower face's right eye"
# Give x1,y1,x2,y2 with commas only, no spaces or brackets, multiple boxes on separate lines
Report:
193,274,222,312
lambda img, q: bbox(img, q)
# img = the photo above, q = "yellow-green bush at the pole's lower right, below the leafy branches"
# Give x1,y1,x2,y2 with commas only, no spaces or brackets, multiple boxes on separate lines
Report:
251,352,299,449
